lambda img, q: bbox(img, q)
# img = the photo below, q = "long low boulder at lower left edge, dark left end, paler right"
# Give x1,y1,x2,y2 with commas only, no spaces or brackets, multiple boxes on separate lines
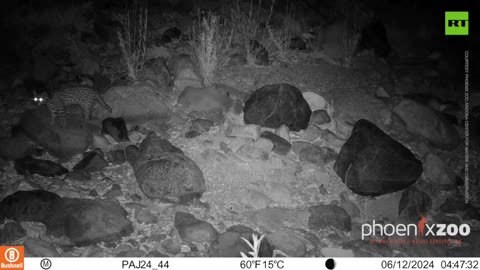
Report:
0,190,133,245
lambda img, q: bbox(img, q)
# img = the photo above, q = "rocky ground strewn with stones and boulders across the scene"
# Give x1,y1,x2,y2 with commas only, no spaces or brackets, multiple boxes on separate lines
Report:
0,0,480,257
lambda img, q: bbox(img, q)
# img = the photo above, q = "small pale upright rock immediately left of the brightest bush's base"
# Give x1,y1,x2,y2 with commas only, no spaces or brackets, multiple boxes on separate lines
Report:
168,54,203,92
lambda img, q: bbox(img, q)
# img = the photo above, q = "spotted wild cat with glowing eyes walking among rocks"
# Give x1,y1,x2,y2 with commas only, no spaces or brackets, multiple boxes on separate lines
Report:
33,85,112,125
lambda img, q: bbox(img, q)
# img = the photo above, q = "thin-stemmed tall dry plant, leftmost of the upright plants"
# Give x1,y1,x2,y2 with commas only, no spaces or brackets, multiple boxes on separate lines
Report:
117,0,148,81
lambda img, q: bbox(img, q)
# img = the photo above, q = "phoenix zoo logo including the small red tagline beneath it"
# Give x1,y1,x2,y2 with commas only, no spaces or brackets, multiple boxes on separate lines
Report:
362,214,471,244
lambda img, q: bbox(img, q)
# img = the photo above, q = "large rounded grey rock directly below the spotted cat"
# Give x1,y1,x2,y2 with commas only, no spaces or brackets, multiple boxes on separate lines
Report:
19,106,91,159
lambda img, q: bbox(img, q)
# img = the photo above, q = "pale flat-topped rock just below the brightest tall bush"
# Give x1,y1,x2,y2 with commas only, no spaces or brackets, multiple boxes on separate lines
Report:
177,86,233,112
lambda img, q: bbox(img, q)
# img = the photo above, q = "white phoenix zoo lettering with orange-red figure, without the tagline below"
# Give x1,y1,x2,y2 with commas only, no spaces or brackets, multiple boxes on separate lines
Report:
362,215,470,240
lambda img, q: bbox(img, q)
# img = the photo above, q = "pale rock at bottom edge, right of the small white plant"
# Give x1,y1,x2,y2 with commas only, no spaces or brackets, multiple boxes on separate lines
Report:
266,231,307,257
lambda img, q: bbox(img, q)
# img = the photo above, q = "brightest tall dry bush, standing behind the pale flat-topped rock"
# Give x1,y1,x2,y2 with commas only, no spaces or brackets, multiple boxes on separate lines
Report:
191,11,233,85
